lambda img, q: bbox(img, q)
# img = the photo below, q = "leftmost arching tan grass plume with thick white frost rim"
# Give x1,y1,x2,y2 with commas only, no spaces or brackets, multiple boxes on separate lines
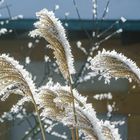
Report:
0,54,36,99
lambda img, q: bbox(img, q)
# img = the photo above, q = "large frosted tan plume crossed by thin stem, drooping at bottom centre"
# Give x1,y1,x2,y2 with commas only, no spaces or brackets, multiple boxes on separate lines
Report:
38,87,120,140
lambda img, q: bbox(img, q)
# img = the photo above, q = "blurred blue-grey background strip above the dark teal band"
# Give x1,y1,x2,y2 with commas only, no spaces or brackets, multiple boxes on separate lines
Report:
0,0,140,20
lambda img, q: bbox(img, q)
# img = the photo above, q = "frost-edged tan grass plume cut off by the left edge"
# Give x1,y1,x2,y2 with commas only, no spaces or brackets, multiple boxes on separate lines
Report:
0,55,35,99
